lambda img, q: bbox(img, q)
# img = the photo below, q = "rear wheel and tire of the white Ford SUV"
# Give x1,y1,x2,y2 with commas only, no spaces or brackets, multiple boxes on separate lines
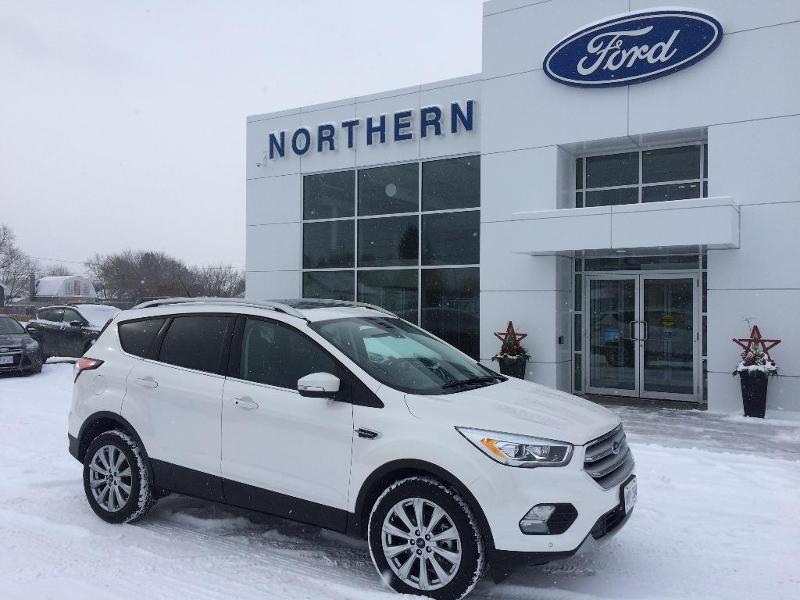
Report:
83,430,156,523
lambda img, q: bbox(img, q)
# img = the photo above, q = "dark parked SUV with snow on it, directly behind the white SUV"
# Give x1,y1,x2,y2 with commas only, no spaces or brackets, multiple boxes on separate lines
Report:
27,304,119,358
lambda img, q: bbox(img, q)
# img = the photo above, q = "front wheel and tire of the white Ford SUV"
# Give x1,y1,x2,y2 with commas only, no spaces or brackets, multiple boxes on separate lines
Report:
367,477,486,600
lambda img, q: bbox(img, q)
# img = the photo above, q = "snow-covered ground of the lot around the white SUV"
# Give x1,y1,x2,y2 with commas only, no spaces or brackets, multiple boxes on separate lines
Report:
0,365,800,600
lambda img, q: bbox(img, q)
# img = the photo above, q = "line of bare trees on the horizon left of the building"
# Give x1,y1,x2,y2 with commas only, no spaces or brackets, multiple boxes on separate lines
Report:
0,223,244,303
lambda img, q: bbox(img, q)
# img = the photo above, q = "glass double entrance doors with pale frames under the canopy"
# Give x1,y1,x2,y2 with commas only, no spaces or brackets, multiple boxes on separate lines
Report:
584,272,699,401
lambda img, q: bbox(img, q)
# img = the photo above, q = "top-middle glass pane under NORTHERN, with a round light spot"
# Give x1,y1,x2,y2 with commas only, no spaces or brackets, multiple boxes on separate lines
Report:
358,163,419,215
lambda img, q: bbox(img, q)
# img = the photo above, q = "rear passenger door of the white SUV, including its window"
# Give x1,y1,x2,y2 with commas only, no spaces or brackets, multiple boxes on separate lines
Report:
122,314,234,500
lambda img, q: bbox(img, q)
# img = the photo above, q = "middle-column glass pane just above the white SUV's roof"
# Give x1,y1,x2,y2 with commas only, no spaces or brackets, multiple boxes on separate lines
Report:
357,269,419,323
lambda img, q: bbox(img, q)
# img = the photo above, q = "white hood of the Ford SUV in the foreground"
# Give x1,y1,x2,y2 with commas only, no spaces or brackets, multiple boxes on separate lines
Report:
406,378,620,445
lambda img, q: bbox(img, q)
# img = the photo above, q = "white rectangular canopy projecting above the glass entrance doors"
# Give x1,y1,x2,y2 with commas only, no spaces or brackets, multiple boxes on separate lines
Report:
512,197,739,254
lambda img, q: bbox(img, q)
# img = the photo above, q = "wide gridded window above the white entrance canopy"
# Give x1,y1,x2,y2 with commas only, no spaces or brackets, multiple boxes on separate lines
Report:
575,144,708,208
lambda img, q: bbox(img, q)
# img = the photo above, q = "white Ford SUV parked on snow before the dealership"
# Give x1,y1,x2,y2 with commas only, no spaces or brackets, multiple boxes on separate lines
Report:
69,299,636,598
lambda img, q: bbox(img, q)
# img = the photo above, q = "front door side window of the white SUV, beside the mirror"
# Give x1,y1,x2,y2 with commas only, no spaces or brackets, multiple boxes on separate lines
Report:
239,319,338,390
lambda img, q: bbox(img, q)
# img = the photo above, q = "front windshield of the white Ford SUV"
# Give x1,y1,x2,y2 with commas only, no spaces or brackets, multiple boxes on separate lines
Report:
311,318,505,394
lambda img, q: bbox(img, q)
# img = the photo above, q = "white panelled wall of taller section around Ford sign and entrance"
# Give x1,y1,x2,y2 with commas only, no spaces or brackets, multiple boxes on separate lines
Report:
481,0,800,411
